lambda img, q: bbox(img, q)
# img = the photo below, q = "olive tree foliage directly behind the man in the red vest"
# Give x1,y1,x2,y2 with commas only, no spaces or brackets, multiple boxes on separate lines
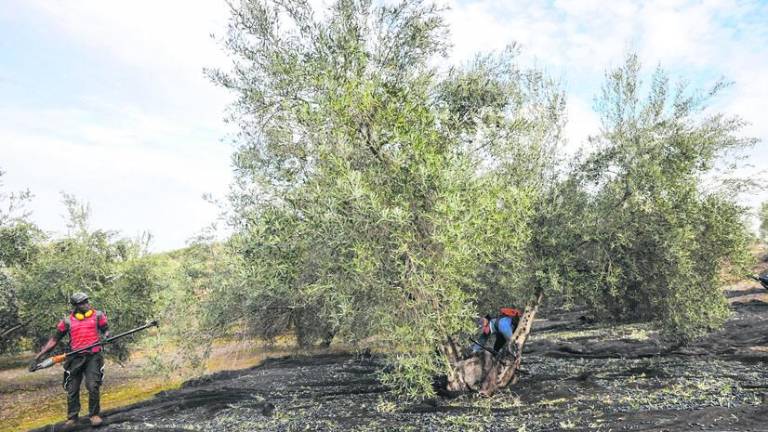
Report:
17,195,158,358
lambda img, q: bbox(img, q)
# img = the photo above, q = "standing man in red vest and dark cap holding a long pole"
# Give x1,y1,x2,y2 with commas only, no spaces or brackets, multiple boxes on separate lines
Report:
35,292,109,427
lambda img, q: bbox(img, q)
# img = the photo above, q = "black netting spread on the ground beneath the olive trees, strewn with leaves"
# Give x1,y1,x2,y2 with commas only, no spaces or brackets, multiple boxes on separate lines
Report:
27,276,768,432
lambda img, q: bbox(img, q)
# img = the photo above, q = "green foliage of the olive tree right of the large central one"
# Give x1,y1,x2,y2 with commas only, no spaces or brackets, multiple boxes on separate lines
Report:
534,55,754,342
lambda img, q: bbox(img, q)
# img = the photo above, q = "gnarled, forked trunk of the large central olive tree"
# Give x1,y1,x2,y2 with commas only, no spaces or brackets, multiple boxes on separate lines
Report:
442,293,543,396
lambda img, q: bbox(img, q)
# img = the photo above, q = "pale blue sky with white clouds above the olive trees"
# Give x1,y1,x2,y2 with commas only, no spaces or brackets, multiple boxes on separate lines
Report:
0,0,768,251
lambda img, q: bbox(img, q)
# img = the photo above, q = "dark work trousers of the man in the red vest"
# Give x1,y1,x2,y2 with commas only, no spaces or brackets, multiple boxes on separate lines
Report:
64,352,104,419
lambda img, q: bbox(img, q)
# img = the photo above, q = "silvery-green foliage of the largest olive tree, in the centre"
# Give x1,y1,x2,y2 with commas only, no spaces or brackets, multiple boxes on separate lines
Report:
210,0,563,396
